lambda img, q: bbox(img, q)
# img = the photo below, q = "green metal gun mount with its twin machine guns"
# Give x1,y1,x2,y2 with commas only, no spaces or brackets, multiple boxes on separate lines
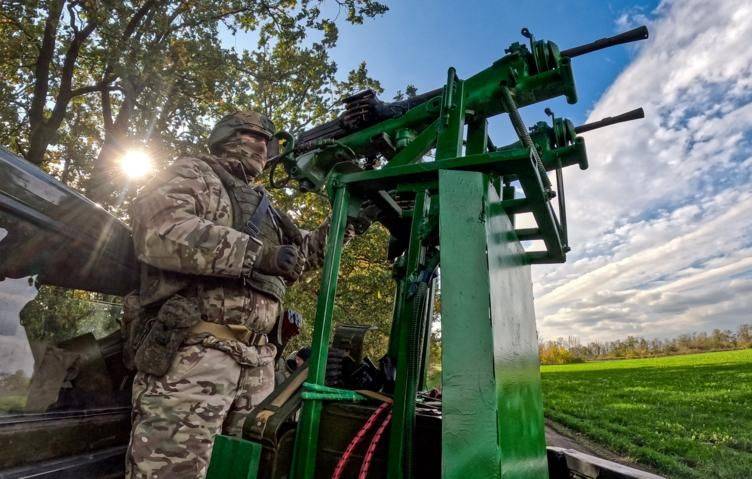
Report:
211,27,647,479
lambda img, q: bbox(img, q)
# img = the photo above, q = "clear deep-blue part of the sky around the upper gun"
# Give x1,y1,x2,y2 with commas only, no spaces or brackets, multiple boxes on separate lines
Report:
332,0,657,143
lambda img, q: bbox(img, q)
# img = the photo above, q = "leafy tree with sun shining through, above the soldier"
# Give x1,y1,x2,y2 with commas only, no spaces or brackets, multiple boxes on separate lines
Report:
0,0,387,203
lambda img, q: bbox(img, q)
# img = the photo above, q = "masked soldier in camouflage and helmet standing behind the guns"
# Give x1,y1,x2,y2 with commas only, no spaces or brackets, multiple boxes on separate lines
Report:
124,111,364,478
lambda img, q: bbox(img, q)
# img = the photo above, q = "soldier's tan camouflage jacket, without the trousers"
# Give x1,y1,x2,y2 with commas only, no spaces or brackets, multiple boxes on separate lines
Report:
131,156,329,338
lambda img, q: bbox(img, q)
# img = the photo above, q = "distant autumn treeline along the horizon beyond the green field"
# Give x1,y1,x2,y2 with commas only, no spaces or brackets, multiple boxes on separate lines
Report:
538,324,752,364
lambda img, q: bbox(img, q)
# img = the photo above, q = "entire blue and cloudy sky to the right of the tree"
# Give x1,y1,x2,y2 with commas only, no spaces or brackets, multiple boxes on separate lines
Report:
326,0,752,341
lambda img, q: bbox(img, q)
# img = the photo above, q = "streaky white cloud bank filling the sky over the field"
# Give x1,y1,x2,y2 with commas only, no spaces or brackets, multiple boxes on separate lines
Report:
534,0,752,339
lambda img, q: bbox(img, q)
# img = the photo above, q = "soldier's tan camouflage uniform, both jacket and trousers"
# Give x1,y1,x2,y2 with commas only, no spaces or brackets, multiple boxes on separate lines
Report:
126,138,328,478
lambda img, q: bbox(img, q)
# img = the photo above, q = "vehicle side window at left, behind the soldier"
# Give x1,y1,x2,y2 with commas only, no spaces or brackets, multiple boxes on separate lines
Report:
0,228,129,415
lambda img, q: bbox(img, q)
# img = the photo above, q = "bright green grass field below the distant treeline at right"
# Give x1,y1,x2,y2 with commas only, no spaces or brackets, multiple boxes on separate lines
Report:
541,349,752,479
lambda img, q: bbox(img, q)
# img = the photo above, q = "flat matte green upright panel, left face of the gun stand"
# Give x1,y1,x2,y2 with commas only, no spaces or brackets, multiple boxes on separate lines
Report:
439,171,501,479
